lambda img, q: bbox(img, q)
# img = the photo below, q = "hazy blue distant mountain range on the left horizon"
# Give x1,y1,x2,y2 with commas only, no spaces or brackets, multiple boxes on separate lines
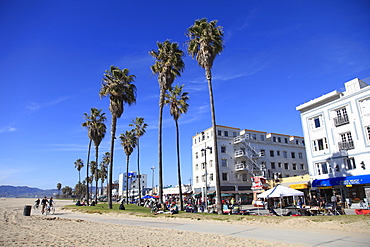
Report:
0,185,61,198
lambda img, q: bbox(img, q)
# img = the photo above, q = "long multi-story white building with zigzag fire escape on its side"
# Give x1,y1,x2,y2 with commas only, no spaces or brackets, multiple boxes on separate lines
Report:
192,125,308,204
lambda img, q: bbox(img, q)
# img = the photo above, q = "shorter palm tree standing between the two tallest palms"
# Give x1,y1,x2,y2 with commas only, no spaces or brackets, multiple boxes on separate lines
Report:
164,85,189,211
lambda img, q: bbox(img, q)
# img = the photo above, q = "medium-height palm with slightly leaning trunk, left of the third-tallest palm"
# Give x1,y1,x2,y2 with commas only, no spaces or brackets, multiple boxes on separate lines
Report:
82,108,106,204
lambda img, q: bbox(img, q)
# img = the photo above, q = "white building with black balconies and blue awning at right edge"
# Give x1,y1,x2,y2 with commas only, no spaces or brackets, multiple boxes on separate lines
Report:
296,78,370,206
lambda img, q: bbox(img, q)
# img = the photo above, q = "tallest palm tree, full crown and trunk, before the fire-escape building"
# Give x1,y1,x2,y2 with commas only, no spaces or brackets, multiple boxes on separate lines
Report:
186,18,224,214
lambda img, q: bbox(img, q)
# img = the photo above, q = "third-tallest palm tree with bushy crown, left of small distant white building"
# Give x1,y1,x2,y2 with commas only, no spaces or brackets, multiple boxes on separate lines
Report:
99,65,136,209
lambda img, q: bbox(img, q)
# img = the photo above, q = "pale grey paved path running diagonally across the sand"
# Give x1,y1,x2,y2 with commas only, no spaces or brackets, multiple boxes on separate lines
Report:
47,206,370,247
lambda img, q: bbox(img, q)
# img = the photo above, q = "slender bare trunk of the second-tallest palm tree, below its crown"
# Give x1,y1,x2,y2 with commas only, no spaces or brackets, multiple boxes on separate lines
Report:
158,86,165,203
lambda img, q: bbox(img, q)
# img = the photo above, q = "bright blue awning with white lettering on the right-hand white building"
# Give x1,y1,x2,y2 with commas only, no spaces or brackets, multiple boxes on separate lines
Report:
312,175,370,187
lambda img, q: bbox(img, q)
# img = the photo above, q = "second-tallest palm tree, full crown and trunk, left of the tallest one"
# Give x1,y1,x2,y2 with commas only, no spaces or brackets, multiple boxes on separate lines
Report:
149,40,185,203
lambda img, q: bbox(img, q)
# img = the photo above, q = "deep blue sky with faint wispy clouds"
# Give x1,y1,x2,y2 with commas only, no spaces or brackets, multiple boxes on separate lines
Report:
0,0,370,189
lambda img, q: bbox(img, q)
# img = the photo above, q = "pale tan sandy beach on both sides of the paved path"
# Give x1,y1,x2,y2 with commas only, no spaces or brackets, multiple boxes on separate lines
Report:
0,198,370,246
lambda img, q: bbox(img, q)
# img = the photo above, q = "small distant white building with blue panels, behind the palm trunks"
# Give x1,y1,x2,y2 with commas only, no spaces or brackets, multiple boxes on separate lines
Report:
118,172,148,197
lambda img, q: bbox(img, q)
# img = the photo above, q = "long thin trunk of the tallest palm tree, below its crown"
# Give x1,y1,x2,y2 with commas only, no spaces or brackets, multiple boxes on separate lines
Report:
206,68,222,214
